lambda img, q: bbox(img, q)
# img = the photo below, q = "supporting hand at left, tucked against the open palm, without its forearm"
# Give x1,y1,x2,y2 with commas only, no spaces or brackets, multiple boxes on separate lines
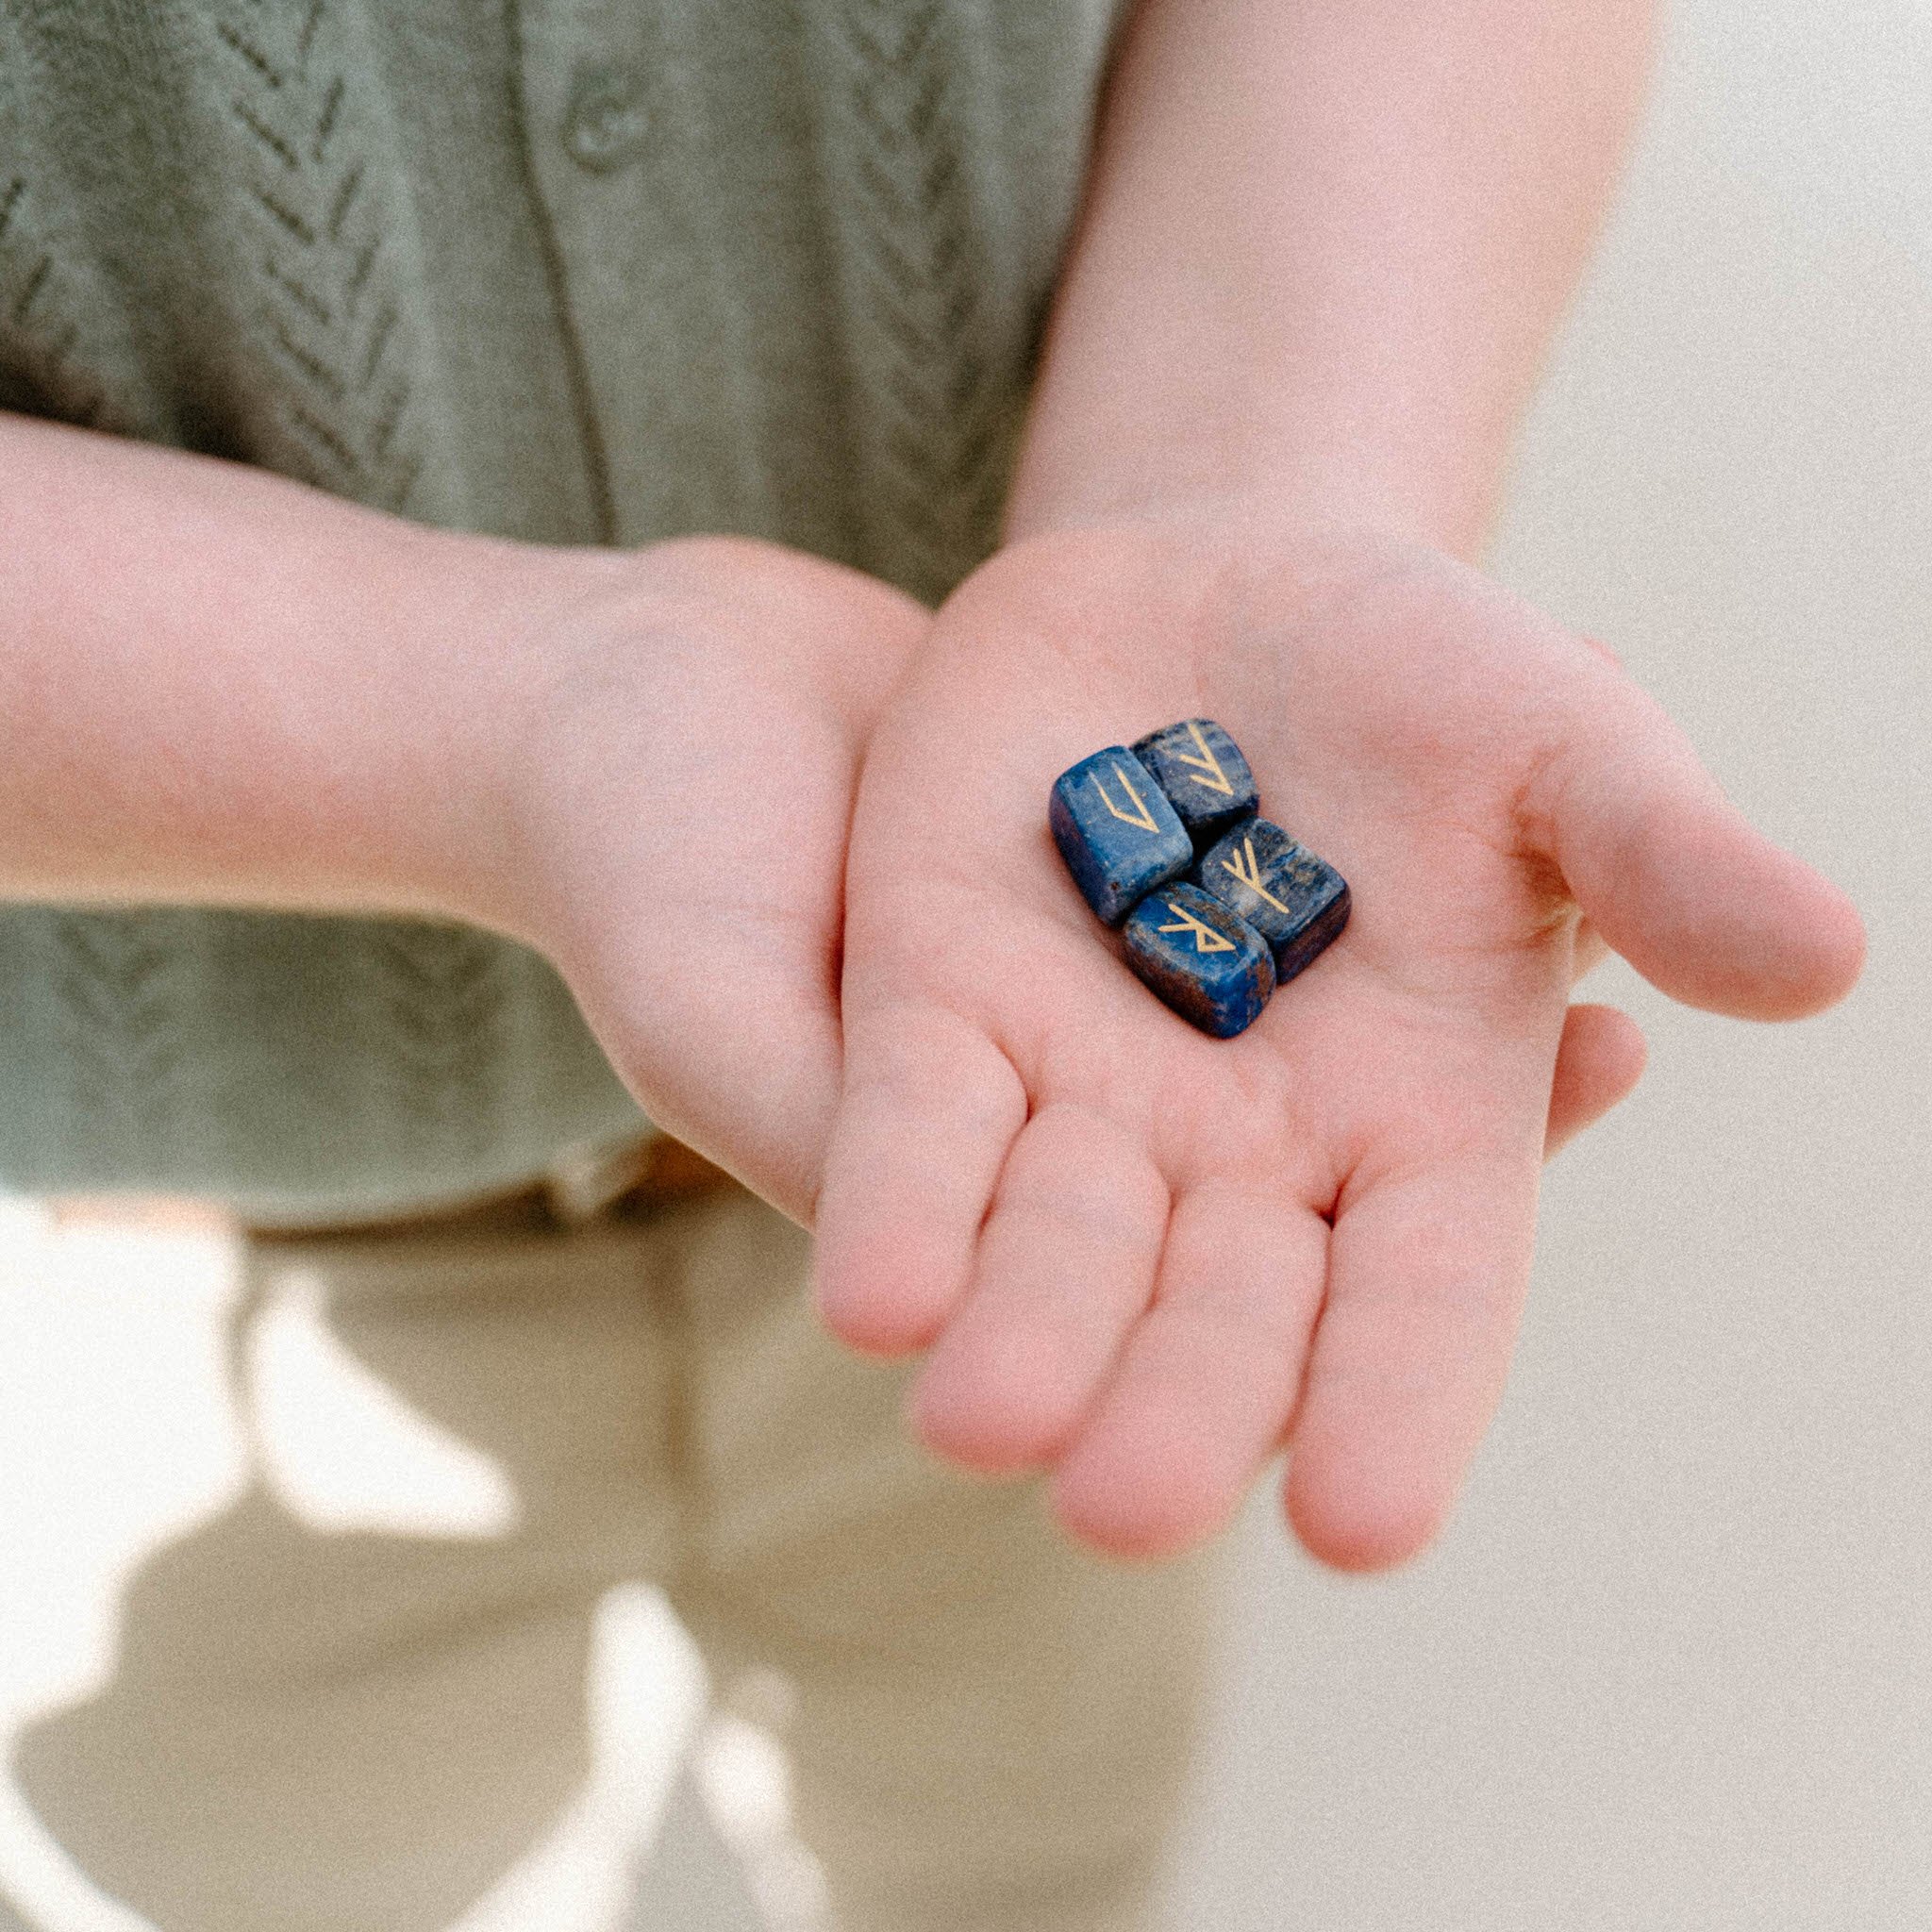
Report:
459,535,931,1217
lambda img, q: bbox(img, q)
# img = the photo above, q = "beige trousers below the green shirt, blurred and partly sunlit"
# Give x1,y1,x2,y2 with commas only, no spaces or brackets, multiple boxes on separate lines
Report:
11,1191,1221,1932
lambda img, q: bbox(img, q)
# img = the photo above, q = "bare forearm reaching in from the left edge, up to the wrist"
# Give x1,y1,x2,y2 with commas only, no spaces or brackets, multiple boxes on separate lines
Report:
0,415,544,931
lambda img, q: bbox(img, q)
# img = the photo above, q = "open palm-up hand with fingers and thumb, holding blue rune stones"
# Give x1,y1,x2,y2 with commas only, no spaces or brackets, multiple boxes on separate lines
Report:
817,518,1862,1569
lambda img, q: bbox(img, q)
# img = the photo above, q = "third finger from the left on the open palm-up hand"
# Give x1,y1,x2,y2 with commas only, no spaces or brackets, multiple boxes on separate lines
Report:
1053,1184,1327,1557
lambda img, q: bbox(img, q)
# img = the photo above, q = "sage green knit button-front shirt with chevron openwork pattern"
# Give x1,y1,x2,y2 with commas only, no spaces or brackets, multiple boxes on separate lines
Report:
0,0,1126,1219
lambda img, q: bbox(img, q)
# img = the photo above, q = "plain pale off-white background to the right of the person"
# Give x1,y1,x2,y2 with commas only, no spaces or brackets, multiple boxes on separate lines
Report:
1173,0,1932,1932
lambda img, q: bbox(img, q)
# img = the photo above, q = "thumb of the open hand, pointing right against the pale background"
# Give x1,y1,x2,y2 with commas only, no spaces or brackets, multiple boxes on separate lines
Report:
1530,669,1864,1020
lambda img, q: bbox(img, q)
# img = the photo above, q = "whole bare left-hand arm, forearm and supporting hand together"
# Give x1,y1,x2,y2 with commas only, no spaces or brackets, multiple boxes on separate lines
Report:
0,417,927,1213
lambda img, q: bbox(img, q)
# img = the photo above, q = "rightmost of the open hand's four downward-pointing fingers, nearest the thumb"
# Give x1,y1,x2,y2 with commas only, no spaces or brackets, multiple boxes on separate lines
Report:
1287,1148,1538,1571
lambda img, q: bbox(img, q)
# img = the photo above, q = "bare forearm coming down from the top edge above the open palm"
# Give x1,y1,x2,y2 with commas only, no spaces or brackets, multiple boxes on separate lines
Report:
1007,0,1652,557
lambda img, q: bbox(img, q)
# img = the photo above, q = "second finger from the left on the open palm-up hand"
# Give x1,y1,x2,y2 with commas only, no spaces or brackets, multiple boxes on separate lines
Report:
914,1105,1169,1474
